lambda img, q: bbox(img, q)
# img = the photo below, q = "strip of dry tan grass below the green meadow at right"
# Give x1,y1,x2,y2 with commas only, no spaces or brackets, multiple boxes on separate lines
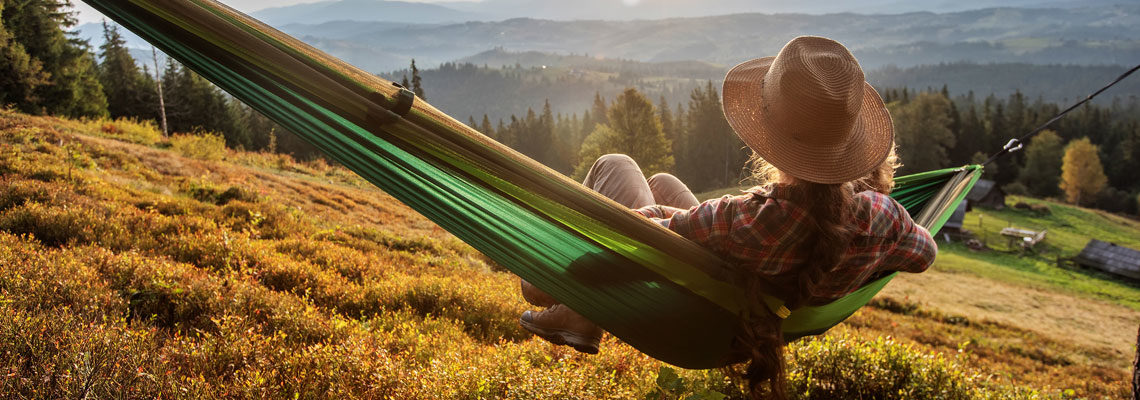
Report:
882,266,1140,366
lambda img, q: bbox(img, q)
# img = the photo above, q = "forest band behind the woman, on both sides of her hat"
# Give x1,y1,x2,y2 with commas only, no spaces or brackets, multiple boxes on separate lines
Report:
469,82,1140,214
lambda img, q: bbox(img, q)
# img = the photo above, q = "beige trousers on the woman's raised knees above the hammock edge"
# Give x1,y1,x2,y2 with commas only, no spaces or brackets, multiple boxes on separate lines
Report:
581,154,700,210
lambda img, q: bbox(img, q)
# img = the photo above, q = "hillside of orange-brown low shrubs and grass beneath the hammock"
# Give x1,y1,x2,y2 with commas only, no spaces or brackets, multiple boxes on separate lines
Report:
0,111,1127,399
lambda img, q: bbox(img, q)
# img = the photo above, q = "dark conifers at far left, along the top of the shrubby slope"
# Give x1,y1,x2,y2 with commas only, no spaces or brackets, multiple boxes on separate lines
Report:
0,0,318,157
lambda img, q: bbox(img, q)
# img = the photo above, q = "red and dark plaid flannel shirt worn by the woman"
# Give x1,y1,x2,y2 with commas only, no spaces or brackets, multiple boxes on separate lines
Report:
635,185,938,303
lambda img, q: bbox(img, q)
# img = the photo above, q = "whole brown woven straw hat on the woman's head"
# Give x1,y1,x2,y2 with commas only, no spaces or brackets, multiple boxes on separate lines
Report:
724,36,895,183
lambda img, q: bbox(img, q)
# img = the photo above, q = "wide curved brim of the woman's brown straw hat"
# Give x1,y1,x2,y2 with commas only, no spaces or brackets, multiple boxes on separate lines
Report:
723,57,895,183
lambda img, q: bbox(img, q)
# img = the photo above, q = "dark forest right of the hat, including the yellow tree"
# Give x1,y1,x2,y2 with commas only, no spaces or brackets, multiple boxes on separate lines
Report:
880,87,1140,214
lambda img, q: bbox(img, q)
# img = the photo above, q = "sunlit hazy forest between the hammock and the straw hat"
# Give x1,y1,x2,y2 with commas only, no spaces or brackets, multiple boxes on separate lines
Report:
467,82,750,191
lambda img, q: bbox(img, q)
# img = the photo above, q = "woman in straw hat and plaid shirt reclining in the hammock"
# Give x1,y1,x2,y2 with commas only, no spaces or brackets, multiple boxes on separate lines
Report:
520,36,937,393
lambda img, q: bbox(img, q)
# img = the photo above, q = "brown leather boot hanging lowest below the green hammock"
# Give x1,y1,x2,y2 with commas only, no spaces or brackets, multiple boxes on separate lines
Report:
519,304,602,354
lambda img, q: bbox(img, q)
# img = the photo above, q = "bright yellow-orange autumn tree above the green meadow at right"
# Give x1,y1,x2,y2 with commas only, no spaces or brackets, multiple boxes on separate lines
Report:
1060,137,1108,205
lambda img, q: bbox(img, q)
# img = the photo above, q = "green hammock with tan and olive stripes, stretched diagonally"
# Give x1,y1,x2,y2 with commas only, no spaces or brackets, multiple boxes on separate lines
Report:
84,0,980,368
